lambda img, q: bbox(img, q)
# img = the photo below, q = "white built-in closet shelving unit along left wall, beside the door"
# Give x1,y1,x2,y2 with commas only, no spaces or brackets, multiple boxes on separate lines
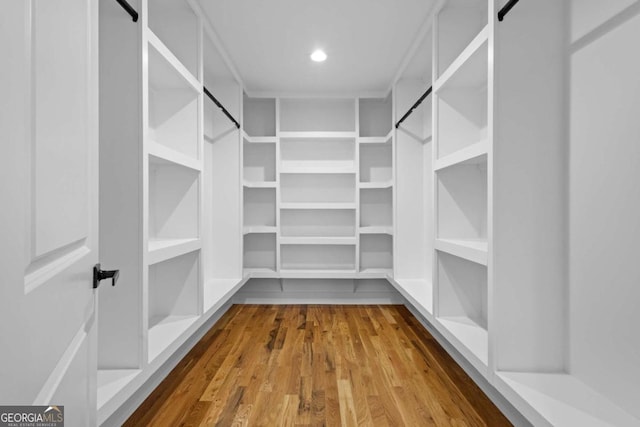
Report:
98,0,244,424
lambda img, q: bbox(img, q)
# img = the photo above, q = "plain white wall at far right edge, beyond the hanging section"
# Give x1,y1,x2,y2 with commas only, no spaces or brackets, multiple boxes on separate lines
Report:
568,0,640,417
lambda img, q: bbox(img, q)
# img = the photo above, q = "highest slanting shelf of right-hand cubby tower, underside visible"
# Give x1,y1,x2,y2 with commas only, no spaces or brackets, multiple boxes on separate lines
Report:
433,26,489,93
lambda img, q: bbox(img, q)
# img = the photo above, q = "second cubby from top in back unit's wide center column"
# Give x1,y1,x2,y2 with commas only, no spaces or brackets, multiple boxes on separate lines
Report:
280,138,356,173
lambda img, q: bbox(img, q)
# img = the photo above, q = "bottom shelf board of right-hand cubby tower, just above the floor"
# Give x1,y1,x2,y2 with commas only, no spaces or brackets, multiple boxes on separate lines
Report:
437,316,489,371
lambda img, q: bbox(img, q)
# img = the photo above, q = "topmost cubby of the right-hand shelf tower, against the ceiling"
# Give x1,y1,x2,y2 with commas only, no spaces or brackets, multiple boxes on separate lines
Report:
436,0,489,76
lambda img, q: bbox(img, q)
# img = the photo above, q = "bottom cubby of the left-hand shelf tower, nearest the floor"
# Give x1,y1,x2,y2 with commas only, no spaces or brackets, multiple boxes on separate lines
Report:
148,251,200,361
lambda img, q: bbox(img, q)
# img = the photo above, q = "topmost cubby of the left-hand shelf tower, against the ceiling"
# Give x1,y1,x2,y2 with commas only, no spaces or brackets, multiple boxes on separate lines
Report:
147,0,200,78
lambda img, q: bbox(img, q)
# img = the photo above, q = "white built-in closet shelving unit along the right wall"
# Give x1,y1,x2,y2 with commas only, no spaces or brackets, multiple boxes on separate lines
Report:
390,0,639,426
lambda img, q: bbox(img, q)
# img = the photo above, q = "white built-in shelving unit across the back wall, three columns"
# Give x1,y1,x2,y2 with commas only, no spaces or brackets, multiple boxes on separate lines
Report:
243,96,393,279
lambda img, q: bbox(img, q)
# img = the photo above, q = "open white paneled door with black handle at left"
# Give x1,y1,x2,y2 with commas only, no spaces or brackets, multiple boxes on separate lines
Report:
0,0,100,426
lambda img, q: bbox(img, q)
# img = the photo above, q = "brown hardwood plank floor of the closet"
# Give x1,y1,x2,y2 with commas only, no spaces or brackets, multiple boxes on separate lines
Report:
125,305,511,427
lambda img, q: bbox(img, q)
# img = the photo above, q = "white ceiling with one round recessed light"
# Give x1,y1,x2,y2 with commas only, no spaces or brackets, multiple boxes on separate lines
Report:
199,0,435,94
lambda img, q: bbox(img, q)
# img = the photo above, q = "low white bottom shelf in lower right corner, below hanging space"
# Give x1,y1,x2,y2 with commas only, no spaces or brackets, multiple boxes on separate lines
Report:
496,372,640,427
